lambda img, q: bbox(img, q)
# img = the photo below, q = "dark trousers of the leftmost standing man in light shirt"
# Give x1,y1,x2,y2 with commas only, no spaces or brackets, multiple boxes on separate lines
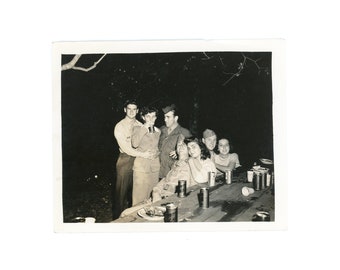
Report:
112,153,135,219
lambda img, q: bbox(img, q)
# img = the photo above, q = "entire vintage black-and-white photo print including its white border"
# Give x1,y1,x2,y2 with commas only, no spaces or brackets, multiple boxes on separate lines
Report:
53,40,286,231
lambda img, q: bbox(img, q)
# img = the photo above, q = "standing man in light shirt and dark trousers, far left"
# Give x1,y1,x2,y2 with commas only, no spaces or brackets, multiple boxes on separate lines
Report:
112,100,152,219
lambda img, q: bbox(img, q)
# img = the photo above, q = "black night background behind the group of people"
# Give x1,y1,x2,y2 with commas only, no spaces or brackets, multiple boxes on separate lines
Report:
61,52,273,222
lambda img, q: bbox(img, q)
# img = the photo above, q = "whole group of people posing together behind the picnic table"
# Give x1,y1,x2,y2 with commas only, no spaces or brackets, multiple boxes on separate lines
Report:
113,100,241,218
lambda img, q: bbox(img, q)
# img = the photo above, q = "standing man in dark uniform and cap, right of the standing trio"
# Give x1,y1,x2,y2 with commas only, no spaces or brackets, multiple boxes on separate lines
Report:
159,104,192,179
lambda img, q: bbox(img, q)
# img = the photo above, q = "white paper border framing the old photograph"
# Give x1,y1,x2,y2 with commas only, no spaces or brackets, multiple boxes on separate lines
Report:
52,39,288,232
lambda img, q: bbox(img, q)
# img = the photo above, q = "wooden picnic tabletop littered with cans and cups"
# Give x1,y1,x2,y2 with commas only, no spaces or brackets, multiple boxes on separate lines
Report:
112,173,275,223
